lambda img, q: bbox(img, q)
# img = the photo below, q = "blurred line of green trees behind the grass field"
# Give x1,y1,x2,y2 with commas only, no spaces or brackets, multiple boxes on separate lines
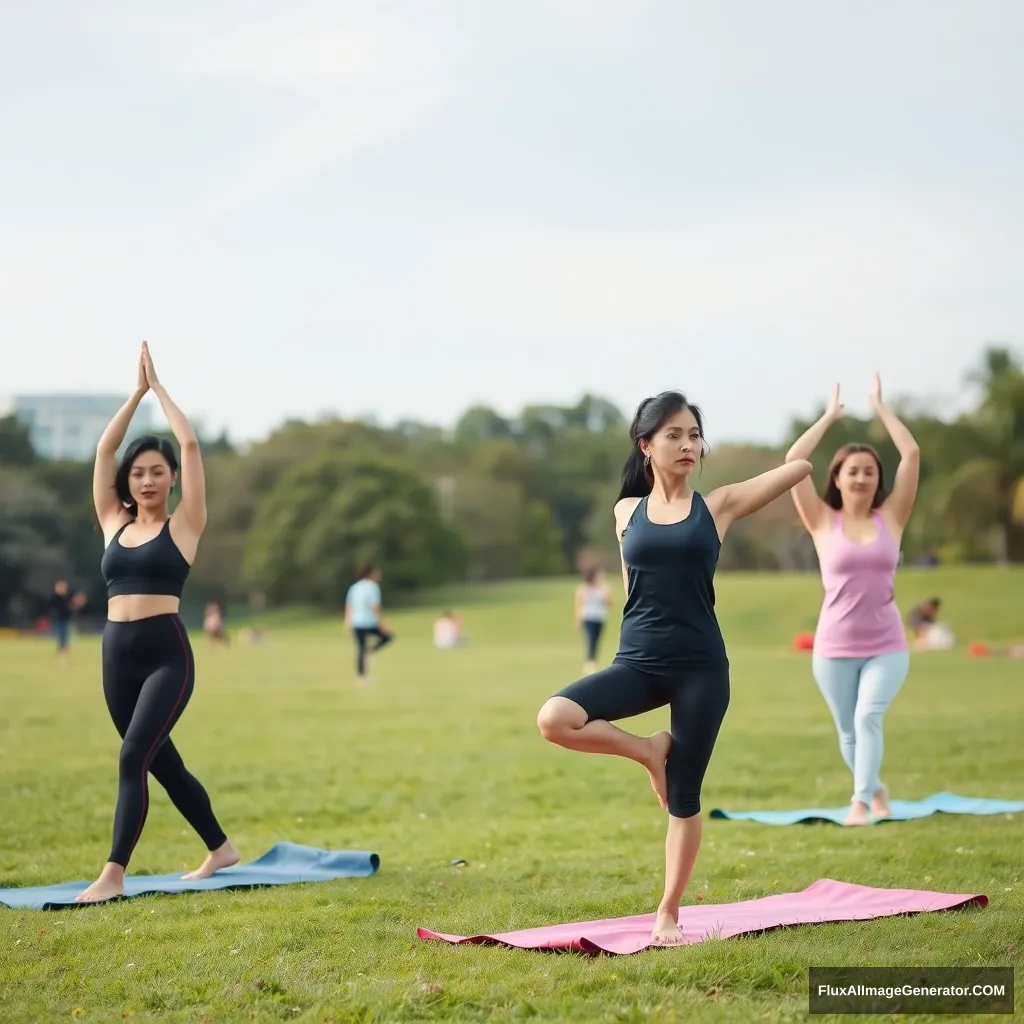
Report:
0,348,1024,625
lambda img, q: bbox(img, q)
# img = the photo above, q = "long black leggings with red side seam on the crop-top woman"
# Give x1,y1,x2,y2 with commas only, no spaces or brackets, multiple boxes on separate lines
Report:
103,615,227,867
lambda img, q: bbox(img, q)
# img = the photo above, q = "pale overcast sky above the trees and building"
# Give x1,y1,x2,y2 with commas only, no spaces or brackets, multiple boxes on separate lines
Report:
0,0,1024,443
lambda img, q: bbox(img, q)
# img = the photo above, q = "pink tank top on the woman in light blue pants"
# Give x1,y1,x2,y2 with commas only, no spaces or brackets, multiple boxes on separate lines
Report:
814,512,907,657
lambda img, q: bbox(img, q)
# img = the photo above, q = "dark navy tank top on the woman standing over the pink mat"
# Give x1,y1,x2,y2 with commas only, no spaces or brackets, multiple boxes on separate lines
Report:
615,492,729,672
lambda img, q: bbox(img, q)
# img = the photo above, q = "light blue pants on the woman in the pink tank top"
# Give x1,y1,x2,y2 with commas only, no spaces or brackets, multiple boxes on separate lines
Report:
812,651,910,807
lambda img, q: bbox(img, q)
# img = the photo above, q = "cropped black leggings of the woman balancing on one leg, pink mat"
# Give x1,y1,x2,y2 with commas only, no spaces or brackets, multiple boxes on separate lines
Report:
556,663,729,818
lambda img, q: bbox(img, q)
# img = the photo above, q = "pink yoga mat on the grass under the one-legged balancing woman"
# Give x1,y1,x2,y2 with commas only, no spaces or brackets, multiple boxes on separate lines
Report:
416,879,988,953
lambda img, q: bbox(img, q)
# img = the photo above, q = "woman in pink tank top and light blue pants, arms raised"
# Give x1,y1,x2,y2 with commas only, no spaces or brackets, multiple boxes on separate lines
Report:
786,374,920,825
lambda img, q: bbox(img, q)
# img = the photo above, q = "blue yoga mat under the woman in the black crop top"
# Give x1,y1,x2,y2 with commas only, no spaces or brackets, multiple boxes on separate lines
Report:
0,843,381,910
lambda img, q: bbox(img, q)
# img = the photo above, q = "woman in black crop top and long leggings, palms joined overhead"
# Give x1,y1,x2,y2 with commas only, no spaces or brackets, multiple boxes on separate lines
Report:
78,342,239,902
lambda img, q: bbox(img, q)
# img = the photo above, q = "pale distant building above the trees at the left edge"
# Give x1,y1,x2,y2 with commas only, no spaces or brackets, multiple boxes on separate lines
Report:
0,394,153,462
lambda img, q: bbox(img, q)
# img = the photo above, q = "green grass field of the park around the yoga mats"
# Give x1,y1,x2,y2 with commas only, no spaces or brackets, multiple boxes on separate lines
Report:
0,569,1024,1024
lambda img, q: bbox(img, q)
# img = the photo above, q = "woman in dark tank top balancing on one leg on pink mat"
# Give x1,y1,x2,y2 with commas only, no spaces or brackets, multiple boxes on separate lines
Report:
538,391,811,944
